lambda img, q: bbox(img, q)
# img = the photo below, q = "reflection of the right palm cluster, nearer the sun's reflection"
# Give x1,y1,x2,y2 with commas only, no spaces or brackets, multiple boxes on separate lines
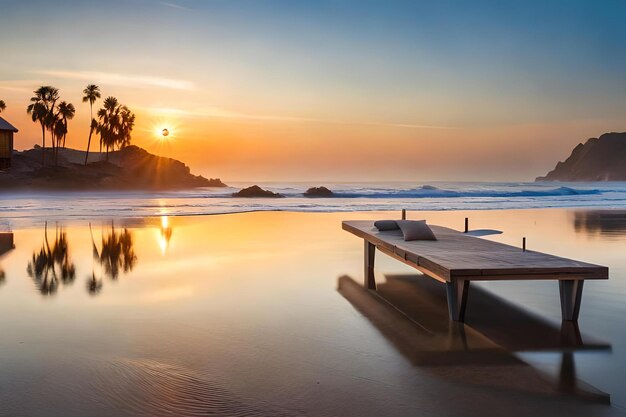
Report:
94,223,137,279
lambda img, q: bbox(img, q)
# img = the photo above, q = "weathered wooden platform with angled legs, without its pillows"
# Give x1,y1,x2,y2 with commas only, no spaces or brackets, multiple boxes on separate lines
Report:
342,221,609,321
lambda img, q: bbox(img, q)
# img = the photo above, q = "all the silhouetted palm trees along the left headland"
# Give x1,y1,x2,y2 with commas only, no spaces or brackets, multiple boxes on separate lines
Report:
25,84,135,165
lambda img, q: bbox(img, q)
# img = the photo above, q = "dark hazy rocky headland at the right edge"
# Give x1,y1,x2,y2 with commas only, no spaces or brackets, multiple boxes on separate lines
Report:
535,133,626,181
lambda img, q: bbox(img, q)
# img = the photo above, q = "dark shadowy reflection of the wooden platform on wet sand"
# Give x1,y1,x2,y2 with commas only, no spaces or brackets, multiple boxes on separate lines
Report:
338,276,610,403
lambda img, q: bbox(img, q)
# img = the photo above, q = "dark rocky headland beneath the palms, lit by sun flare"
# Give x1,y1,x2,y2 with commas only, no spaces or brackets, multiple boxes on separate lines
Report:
0,146,226,191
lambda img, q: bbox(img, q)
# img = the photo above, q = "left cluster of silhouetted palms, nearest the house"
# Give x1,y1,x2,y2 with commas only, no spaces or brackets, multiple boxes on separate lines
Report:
26,85,76,165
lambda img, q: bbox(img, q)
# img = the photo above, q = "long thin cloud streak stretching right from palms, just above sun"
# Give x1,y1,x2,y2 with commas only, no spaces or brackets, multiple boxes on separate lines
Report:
135,106,456,129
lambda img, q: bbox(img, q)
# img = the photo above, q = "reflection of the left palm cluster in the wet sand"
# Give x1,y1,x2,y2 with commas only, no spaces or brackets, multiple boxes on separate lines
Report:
26,223,76,295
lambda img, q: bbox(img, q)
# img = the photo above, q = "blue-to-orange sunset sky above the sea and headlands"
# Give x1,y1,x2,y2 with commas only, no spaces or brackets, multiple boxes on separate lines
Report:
0,0,626,181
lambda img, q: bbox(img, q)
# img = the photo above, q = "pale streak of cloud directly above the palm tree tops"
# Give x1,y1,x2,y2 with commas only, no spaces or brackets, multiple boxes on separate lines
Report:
34,71,195,90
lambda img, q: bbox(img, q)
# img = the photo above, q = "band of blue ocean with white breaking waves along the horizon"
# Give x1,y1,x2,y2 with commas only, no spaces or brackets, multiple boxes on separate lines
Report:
0,182,626,229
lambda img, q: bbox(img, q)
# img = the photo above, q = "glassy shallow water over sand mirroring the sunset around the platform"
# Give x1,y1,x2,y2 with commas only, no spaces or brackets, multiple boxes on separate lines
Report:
0,209,626,416
